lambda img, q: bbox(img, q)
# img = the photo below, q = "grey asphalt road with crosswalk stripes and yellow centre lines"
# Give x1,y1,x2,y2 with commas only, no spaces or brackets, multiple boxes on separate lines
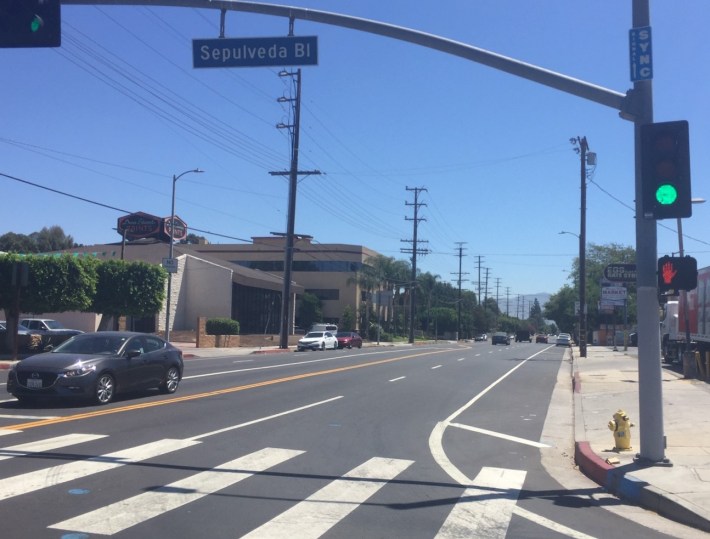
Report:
0,342,696,539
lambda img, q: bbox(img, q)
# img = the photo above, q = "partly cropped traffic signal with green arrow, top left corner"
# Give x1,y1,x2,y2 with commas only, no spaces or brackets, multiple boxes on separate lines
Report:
0,0,62,48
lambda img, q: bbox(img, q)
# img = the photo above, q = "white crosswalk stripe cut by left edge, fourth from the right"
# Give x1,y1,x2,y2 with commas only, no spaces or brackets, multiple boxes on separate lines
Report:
0,439,200,500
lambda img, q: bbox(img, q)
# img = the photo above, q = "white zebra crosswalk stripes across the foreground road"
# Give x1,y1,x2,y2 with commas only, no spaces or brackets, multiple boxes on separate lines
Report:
0,433,525,539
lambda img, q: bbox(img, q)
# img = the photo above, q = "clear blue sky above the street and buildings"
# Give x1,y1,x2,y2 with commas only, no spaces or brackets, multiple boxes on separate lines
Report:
0,0,710,301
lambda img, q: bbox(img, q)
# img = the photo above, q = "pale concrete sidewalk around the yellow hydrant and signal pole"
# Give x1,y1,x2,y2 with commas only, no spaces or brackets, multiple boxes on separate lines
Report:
572,346,710,531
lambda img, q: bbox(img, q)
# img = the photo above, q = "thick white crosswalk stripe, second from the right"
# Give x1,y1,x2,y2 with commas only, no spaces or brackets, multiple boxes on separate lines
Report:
242,457,414,539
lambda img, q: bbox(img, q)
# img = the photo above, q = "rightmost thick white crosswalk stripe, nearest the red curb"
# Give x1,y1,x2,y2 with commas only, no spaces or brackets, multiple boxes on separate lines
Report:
436,467,526,539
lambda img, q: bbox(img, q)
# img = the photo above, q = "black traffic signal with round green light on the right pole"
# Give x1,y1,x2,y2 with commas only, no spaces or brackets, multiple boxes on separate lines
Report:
641,120,692,219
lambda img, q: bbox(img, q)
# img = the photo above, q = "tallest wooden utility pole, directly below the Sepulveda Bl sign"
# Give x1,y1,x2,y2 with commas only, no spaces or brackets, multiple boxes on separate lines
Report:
269,68,320,349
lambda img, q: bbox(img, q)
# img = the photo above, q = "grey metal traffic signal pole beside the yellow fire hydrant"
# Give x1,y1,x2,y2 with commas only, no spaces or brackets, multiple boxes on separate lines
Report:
632,0,668,463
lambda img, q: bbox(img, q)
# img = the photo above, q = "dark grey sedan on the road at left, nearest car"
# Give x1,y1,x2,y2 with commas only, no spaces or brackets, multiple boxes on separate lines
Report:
7,331,183,404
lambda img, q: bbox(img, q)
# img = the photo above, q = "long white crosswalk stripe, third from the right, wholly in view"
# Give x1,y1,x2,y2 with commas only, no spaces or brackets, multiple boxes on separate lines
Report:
49,447,303,535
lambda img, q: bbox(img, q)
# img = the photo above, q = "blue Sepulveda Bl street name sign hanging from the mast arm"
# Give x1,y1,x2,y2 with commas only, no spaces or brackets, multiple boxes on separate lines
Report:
192,36,318,68
